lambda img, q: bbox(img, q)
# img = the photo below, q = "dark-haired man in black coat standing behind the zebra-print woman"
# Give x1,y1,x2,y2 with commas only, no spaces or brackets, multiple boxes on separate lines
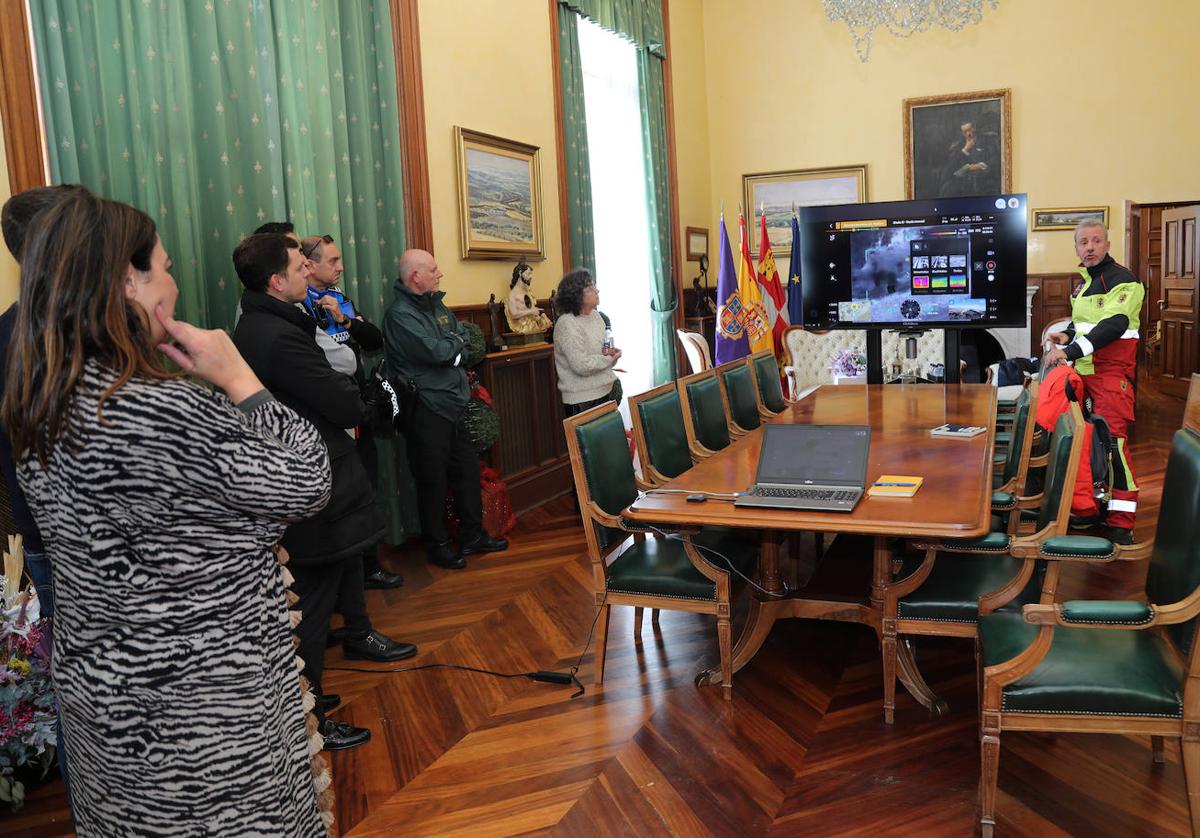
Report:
233,233,416,749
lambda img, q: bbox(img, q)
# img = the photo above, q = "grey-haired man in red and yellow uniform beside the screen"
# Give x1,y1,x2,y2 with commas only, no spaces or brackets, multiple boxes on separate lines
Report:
1046,221,1145,544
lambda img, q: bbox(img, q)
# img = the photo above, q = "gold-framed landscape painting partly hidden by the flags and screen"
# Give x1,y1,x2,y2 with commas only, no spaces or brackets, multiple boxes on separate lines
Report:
742,163,866,254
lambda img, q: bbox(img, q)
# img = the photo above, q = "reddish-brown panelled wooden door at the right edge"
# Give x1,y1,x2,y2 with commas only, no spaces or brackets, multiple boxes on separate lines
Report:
1151,205,1200,399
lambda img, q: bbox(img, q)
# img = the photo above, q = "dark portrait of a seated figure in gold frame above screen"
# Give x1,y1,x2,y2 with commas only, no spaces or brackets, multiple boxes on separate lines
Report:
904,89,1013,198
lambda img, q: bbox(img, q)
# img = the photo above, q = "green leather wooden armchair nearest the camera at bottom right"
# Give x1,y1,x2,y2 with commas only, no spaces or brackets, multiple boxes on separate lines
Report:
977,376,1200,836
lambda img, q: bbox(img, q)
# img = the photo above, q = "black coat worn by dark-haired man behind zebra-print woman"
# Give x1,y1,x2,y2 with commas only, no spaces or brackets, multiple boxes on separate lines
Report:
233,291,383,563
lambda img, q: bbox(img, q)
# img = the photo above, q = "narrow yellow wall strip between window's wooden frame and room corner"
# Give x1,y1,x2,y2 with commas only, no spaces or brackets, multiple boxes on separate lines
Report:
670,0,716,282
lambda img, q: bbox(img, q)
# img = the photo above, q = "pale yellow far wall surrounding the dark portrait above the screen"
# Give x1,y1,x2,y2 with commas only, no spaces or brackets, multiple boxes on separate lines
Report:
691,0,1200,273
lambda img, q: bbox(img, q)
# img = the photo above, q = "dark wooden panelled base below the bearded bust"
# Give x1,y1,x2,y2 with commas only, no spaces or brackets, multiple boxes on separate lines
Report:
475,343,574,515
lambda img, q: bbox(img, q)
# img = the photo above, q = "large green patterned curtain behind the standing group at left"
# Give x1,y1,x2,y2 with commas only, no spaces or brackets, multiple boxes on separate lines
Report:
30,0,416,541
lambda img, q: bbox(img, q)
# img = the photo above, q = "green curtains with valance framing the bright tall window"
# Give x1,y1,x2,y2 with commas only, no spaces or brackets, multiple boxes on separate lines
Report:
558,0,678,384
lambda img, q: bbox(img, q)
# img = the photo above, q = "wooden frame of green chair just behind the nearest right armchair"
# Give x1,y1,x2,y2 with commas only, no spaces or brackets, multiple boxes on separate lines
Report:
881,393,1084,724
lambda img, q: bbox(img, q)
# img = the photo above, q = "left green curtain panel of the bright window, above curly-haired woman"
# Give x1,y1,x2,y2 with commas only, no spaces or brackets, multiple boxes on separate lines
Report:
558,5,596,274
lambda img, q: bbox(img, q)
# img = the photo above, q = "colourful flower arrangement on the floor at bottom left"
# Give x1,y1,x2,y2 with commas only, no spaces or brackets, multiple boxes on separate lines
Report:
0,539,58,812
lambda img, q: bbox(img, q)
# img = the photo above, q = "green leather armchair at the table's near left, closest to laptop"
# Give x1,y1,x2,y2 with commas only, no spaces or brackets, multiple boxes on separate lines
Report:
563,402,757,699
